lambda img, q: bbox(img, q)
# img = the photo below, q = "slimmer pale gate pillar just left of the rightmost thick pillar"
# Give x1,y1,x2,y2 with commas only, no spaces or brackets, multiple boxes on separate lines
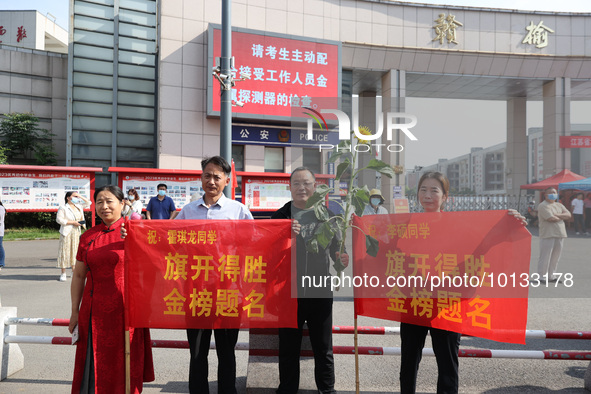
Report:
505,97,528,194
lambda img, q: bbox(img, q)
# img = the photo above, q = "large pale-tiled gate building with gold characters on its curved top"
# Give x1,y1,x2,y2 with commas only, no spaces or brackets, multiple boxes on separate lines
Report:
4,0,591,209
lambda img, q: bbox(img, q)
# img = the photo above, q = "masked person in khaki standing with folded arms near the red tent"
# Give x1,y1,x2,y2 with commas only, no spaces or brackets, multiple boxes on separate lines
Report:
538,187,571,282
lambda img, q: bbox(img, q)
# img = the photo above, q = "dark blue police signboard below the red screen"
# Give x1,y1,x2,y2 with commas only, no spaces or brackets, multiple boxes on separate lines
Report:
232,126,339,148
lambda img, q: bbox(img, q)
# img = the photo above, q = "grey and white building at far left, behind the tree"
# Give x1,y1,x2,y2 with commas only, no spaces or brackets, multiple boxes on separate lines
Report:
0,11,68,165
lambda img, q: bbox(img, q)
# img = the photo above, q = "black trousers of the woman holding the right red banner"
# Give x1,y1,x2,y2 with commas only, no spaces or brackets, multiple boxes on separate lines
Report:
400,323,462,394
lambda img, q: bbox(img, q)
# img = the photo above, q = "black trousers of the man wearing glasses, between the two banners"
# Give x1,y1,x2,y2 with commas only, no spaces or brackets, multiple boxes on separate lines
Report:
277,298,336,394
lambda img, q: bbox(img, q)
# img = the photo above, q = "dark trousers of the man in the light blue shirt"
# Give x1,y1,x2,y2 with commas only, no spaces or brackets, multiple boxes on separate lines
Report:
187,329,238,394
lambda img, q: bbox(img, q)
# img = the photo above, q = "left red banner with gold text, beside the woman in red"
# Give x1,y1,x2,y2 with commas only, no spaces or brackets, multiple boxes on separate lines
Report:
125,220,297,329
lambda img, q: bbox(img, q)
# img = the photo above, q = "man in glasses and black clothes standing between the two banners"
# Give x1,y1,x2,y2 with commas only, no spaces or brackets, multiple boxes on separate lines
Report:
271,167,349,394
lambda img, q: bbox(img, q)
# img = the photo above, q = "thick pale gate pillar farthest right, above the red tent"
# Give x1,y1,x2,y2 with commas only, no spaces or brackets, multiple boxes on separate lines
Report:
543,78,571,178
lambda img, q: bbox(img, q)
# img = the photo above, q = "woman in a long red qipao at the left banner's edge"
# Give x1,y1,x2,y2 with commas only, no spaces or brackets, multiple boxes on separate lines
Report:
69,185,154,394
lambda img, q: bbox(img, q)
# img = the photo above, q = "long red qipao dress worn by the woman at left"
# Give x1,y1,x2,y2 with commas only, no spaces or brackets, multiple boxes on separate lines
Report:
72,219,154,394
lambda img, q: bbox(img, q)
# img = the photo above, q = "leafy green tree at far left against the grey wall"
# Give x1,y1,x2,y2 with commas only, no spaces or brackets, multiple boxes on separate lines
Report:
0,112,57,165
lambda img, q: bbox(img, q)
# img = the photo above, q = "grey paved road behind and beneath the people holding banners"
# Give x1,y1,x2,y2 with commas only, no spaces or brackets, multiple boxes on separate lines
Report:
0,229,591,394
